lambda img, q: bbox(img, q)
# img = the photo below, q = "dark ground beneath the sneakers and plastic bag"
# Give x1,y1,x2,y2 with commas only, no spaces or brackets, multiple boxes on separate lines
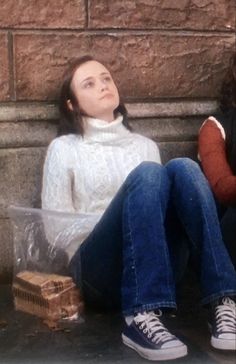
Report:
0,285,236,364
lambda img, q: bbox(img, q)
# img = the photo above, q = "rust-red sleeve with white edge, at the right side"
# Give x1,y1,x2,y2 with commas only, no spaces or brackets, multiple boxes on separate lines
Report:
198,118,236,204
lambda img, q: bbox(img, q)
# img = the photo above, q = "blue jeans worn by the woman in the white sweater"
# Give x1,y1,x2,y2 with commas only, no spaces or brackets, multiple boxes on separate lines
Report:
70,158,236,315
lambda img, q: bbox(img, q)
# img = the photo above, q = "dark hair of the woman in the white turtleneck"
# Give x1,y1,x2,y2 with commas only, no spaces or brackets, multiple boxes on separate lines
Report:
58,55,131,136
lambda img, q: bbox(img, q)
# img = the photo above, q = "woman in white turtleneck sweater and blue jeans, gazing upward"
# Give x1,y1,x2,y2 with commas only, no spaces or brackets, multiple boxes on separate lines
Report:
42,56,236,360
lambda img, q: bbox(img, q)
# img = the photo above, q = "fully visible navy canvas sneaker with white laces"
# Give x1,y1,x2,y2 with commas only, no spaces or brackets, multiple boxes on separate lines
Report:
122,311,187,360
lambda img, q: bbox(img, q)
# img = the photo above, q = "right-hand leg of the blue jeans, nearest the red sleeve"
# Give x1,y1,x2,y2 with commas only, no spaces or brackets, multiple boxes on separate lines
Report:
166,158,236,303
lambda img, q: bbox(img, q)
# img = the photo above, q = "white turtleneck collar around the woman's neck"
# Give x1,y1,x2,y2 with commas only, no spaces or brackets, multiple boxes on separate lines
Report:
83,115,130,143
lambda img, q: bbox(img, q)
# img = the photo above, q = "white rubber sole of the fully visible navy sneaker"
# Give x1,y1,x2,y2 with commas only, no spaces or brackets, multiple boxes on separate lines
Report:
122,334,188,360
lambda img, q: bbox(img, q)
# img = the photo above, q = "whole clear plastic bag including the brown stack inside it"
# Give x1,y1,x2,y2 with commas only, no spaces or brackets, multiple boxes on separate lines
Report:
8,206,99,321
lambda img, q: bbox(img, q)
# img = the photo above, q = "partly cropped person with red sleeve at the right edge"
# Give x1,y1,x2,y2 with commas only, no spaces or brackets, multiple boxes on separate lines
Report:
199,53,236,269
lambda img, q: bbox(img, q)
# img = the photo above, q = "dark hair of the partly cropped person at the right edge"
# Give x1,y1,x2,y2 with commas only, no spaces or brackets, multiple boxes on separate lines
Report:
219,52,236,111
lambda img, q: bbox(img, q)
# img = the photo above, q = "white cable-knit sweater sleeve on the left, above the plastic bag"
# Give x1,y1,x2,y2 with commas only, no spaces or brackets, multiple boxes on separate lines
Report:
41,139,75,212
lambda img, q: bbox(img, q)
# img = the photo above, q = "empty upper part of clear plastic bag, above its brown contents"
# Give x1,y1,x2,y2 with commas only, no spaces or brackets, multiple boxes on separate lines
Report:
8,206,100,275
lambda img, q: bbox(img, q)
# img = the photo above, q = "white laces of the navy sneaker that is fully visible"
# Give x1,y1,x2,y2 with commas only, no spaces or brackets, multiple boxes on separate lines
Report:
134,311,175,344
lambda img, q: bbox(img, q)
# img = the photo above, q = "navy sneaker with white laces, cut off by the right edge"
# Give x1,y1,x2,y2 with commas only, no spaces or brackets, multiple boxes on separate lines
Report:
209,297,236,350
